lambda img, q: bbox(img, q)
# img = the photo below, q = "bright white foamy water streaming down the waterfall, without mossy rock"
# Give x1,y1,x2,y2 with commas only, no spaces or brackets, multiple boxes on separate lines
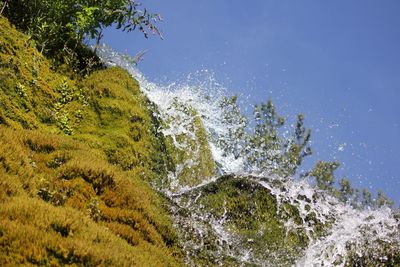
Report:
98,46,400,266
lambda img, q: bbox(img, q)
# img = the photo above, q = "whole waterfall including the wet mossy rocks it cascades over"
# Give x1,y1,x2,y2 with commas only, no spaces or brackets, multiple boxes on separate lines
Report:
98,46,400,266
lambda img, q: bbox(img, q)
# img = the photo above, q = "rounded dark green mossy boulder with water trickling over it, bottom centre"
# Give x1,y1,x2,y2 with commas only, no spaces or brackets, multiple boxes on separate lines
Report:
178,176,317,266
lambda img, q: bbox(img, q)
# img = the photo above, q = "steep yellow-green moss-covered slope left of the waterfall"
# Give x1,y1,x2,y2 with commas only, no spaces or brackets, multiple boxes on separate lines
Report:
0,18,181,266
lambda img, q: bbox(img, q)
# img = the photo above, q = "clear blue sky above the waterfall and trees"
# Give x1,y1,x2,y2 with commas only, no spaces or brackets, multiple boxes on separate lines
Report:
103,0,400,203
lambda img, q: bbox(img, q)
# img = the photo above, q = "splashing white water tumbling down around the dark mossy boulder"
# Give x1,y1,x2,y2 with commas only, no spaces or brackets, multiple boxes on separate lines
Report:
98,46,400,266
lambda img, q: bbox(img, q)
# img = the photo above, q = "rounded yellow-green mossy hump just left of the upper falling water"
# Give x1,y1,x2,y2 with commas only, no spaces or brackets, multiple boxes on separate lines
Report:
76,68,172,178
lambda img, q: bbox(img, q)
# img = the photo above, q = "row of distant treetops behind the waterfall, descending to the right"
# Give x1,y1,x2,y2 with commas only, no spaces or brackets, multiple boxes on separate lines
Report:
221,97,393,208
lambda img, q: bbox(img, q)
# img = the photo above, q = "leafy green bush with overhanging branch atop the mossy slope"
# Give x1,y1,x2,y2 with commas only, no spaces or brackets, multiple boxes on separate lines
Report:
3,0,161,72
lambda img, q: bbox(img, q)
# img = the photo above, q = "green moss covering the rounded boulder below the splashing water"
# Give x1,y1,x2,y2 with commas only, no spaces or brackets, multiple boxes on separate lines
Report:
175,176,309,266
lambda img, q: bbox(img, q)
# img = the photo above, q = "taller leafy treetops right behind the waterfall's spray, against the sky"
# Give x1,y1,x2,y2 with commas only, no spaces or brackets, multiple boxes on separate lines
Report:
219,97,311,177
